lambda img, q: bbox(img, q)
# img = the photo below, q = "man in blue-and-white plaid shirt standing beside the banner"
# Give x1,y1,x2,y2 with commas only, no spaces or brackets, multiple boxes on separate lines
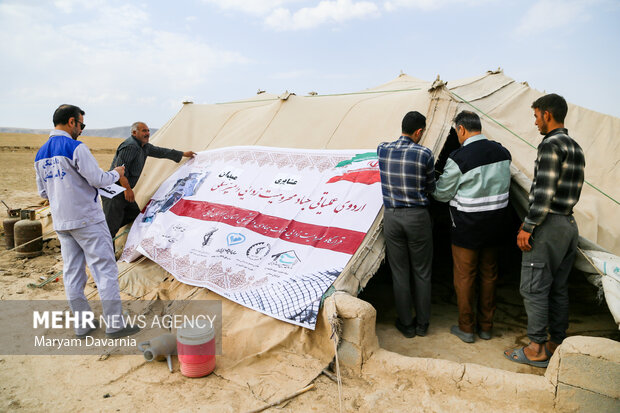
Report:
377,111,435,338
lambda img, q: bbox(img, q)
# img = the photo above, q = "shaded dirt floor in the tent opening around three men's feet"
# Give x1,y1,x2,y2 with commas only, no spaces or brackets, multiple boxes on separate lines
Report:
359,257,620,375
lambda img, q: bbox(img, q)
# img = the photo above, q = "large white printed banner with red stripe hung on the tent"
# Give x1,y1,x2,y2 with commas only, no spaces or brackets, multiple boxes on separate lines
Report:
121,147,382,329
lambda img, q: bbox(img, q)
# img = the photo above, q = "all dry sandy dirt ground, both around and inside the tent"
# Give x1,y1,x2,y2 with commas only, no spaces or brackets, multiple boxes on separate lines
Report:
0,134,620,412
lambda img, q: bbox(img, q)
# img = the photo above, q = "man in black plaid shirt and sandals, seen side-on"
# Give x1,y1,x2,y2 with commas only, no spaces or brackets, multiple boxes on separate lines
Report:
504,94,585,367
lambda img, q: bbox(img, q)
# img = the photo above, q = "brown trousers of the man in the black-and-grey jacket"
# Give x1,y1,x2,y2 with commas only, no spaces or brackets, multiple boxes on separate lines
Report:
452,244,497,333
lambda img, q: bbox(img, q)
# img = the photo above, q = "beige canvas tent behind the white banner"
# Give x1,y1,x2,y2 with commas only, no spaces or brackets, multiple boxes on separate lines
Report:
117,71,620,400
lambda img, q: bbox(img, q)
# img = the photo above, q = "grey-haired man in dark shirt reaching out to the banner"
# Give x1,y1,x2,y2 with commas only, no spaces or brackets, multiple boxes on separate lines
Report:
102,122,196,237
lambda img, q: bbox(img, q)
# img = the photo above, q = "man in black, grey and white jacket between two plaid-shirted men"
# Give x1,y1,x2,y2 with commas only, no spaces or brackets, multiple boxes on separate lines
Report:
433,111,511,343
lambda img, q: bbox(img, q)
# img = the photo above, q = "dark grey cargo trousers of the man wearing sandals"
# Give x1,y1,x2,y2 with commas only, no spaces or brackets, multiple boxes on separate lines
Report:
520,214,579,344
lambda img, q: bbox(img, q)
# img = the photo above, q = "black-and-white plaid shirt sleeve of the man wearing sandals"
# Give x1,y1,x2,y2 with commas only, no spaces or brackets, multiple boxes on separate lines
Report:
523,143,562,233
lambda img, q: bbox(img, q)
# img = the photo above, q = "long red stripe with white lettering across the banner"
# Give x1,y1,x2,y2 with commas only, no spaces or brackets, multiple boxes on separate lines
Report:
170,199,366,254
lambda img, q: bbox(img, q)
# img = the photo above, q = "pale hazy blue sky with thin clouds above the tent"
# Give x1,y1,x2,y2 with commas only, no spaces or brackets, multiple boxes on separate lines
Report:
0,0,620,128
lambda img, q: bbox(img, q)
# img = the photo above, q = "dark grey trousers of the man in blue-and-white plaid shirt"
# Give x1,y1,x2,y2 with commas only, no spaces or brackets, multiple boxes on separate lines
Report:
383,208,433,325
